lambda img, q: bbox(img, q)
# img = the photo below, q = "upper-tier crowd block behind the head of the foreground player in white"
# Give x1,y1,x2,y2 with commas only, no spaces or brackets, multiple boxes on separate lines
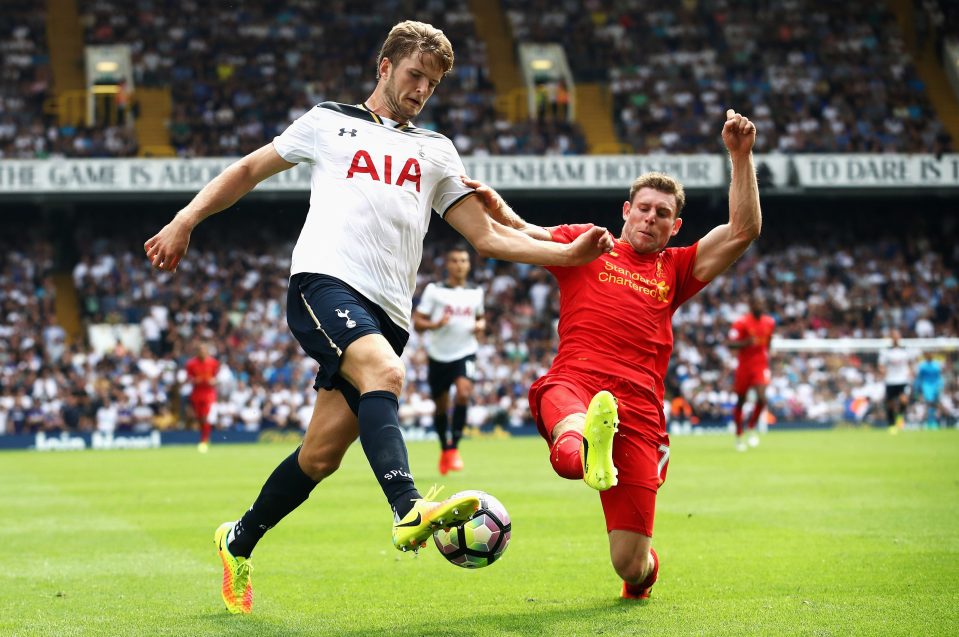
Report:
80,0,585,157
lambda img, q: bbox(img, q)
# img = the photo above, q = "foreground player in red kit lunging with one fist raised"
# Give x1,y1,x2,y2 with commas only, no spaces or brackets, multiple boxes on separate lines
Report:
466,109,762,599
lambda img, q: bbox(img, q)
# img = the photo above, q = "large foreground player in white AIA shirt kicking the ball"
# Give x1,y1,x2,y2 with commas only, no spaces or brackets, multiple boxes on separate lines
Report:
144,21,613,613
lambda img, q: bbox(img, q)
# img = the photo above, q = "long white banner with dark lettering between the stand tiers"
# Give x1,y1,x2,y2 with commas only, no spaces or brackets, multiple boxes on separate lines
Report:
0,153,959,199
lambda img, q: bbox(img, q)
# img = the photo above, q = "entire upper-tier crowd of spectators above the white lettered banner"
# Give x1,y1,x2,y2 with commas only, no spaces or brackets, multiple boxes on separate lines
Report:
11,0,959,158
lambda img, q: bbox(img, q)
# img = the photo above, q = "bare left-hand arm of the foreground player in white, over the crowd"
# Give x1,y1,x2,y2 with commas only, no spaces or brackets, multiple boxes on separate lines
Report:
143,143,296,272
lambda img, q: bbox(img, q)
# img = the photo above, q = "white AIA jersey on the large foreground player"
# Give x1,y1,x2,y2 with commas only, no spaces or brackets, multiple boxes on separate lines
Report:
273,102,473,331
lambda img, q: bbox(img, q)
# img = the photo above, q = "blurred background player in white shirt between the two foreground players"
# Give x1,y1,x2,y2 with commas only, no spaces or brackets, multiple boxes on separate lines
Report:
413,246,486,475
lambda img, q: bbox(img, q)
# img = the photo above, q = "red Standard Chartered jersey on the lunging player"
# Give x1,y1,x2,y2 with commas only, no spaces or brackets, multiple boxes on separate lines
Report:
547,225,706,400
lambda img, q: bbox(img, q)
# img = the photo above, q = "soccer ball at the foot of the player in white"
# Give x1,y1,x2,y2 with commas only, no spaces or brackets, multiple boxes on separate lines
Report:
433,491,512,568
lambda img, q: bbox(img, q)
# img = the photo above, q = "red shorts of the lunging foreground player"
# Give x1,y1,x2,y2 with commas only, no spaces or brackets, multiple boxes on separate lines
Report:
529,370,669,537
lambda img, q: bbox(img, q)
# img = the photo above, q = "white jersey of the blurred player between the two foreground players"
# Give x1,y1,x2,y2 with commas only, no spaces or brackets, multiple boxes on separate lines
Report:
416,283,483,363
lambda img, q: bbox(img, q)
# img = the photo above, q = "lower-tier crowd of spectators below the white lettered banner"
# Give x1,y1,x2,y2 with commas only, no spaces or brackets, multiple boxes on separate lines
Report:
0,204,959,433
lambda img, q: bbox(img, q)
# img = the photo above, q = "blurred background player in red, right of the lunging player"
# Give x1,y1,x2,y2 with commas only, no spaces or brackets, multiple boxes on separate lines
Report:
728,296,776,451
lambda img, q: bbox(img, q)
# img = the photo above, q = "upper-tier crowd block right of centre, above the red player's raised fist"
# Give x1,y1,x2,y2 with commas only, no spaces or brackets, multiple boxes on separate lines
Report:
504,0,953,153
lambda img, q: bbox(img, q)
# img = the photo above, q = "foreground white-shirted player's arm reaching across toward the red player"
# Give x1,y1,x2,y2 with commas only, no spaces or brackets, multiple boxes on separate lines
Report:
444,196,613,266
